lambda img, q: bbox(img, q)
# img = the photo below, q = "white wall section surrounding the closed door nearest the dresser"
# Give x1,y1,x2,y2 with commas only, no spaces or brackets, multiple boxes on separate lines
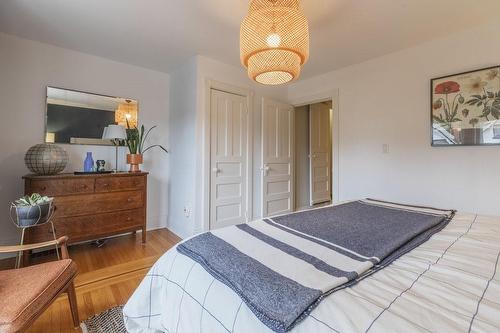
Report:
168,56,287,237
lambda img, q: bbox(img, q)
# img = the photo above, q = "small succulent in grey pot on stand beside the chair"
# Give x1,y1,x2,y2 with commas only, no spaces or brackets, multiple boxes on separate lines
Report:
12,193,54,227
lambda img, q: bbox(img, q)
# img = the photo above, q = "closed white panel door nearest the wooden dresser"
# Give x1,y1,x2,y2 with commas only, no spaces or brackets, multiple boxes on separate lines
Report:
210,89,248,229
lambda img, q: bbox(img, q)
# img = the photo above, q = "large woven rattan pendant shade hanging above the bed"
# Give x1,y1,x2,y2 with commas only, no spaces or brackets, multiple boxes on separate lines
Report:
240,0,309,85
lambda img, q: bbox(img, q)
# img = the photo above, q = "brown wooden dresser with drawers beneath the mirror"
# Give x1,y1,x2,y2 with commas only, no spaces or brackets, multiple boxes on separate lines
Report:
23,172,147,244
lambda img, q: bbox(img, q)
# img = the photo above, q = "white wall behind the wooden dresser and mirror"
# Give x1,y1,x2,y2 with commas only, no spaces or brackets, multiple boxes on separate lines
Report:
0,33,170,244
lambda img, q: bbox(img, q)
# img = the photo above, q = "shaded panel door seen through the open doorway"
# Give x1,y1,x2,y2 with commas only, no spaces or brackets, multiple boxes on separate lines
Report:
309,103,332,206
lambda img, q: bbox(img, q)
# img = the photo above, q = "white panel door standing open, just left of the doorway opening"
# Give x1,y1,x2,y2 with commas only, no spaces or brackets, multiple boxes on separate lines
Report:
261,98,294,217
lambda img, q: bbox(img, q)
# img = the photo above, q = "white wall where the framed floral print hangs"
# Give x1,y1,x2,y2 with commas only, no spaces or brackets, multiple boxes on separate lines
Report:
288,24,500,215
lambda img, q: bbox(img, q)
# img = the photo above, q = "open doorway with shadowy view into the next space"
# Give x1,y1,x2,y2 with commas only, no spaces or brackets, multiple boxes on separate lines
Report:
294,100,333,210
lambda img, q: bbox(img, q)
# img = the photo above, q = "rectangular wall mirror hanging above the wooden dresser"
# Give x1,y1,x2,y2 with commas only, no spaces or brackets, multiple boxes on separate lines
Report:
45,87,139,145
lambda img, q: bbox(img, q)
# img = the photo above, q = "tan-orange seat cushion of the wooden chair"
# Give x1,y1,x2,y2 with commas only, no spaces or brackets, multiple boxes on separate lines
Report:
0,259,77,332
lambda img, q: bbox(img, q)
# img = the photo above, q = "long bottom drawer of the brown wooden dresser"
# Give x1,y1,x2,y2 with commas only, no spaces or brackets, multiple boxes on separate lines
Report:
28,209,144,243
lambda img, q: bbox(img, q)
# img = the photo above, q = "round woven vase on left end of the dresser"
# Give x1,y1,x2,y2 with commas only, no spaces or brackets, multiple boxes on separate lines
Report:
24,143,68,175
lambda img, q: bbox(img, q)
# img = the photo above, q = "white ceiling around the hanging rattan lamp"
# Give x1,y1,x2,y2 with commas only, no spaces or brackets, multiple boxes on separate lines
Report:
0,0,500,78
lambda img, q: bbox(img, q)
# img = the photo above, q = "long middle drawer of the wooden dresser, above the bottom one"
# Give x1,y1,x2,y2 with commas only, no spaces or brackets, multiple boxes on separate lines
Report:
54,191,144,218
